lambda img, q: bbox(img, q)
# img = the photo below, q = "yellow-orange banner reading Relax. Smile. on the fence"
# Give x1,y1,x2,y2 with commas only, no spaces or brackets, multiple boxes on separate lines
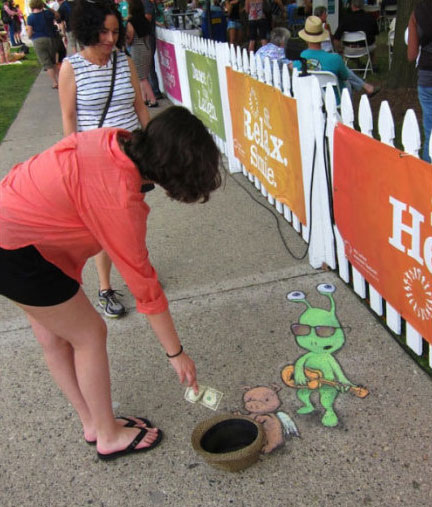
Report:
227,68,306,224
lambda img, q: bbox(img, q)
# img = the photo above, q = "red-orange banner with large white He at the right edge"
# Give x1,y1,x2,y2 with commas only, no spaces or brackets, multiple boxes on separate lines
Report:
334,124,432,343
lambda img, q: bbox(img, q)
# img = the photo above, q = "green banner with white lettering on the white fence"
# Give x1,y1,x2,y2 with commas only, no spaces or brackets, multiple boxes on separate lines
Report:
186,51,225,141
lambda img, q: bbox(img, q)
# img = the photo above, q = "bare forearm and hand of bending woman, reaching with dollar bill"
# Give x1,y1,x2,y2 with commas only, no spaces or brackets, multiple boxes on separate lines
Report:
147,310,198,393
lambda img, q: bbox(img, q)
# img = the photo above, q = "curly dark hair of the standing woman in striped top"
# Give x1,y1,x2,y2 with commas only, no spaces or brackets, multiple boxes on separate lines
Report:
71,0,125,49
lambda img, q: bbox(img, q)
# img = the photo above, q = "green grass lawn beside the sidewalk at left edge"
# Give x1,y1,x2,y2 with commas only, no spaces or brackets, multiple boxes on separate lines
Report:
0,47,41,142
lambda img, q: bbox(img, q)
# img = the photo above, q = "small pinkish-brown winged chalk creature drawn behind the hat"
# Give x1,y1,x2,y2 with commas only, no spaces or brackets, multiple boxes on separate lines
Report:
238,384,300,454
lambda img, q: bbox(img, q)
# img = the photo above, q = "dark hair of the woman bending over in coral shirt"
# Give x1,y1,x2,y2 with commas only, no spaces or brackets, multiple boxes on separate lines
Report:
122,106,222,203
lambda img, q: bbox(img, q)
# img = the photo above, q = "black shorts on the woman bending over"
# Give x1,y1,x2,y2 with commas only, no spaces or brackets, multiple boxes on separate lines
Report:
0,246,80,306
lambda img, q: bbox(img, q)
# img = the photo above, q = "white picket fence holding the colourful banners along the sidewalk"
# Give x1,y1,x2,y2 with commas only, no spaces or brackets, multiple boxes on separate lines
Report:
158,30,432,367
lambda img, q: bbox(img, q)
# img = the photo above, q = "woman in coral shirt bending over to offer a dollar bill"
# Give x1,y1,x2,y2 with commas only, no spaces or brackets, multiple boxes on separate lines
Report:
0,106,221,460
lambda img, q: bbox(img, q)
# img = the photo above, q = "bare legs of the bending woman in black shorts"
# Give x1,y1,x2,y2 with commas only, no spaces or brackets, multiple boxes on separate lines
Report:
19,289,157,453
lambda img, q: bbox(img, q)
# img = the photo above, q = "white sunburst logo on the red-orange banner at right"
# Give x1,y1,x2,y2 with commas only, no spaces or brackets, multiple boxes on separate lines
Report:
403,268,432,320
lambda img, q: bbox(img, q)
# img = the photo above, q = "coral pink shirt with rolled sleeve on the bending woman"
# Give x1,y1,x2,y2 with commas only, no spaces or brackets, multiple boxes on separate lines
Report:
0,128,168,314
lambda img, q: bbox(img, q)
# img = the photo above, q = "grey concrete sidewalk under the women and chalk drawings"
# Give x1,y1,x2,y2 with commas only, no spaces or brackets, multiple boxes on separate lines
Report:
0,73,432,507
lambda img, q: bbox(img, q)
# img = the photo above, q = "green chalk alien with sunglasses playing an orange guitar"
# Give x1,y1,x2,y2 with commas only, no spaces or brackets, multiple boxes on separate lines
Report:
281,283,369,427
